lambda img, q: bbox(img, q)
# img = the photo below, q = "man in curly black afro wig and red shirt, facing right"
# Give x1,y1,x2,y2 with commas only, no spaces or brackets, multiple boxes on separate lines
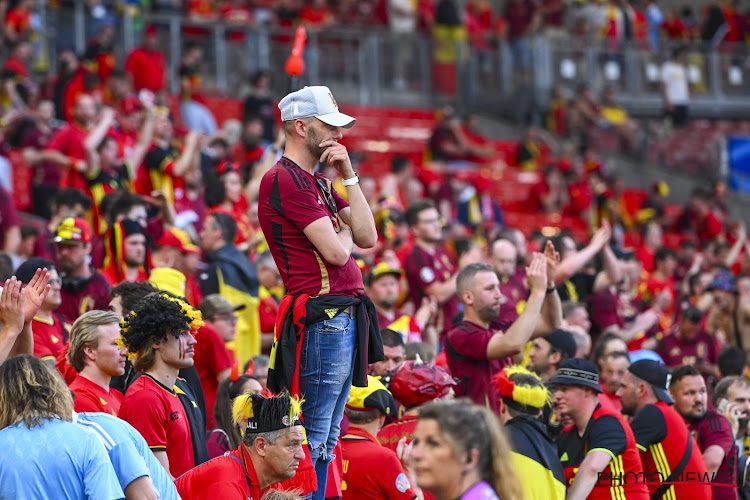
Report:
119,292,208,477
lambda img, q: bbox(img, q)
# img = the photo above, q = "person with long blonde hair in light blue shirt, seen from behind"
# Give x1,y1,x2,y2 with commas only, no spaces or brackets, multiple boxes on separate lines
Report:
0,355,125,500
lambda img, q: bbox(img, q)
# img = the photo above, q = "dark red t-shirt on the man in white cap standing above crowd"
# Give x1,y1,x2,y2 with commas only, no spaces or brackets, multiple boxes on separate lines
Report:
258,157,364,296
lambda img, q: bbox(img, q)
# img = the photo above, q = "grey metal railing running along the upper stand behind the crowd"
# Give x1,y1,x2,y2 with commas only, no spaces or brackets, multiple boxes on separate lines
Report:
26,1,750,119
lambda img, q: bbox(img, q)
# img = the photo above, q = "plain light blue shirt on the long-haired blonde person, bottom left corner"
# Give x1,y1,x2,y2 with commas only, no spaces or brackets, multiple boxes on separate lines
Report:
0,419,125,500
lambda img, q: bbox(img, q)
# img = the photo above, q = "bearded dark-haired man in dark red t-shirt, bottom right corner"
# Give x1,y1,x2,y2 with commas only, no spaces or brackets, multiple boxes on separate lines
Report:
669,365,737,500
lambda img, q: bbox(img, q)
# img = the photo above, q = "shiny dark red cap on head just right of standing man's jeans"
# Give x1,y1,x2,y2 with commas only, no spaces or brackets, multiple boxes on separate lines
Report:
391,361,456,408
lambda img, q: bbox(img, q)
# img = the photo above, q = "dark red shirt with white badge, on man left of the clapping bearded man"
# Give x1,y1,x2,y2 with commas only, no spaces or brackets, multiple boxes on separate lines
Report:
404,245,458,332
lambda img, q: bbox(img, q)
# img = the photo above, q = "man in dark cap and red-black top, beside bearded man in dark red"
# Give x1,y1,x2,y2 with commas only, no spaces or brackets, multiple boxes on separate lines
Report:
617,359,711,498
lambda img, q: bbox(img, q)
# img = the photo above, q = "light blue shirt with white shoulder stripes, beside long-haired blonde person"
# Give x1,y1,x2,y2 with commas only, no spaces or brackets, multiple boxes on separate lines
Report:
75,413,180,500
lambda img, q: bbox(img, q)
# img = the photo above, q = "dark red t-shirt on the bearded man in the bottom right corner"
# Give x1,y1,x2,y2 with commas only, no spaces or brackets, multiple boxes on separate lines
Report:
688,410,737,500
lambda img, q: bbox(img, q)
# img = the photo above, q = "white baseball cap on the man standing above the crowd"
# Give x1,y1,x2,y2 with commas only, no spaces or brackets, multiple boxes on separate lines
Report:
279,85,357,128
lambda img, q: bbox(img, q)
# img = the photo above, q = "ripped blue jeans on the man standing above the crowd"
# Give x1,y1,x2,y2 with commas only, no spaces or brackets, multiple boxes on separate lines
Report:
299,312,357,500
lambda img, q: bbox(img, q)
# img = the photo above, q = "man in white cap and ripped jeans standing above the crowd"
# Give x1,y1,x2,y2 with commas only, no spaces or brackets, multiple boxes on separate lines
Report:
258,87,383,499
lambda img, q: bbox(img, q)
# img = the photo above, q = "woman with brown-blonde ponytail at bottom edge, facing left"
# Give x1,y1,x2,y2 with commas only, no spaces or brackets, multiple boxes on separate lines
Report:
407,399,523,500
